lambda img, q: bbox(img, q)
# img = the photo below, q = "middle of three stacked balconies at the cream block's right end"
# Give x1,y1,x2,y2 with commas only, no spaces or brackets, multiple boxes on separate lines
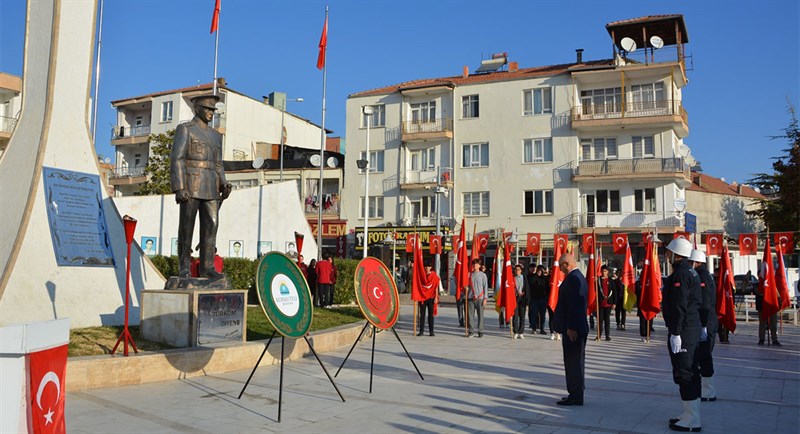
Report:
572,157,692,185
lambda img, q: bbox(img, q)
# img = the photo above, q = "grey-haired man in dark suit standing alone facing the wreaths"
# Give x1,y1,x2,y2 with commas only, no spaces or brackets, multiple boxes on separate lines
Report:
554,253,589,405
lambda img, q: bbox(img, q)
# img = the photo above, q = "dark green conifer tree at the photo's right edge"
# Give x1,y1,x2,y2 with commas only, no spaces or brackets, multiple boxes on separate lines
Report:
749,103,800,231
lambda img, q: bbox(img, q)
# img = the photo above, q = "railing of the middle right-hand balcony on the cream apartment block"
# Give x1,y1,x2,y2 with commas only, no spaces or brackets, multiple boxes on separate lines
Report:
574,157,690,177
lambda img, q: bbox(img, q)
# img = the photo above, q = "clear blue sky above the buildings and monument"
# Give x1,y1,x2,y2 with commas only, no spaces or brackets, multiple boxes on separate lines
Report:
0,0,800,182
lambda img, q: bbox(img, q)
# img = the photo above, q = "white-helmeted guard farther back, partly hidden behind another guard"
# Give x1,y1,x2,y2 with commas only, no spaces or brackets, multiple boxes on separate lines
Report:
689,250,717,401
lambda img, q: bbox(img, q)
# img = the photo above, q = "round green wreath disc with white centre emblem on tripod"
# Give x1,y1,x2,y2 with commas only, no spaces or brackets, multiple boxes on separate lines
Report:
256,252,313,338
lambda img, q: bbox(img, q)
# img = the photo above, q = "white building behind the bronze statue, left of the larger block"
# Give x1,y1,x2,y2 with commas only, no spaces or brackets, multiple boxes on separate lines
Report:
111,79,328,196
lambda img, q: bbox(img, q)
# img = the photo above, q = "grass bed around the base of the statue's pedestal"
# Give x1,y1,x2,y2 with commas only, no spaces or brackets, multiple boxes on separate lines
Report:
68,306,364,357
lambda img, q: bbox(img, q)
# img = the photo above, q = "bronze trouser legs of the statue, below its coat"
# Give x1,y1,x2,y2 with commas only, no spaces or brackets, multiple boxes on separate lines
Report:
178,198,219,277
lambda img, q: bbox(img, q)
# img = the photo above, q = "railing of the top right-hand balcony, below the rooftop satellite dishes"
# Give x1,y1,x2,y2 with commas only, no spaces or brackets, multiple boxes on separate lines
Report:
572,99,687,122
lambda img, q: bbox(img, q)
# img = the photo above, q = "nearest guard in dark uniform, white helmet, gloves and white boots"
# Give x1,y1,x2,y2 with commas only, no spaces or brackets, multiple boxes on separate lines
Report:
661,238,702,432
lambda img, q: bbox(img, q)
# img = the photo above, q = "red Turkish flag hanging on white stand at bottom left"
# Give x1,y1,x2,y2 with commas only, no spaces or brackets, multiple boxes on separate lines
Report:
28,345,67,433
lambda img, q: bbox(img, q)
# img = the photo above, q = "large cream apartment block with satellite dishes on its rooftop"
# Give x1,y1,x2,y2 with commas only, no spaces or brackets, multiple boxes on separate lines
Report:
342,15,691,262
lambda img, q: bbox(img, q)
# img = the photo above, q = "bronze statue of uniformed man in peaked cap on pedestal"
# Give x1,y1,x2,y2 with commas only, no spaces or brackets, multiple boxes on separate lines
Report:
170,95,231,279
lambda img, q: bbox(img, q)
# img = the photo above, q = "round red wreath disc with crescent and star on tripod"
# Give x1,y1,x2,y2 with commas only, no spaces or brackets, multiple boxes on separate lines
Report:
354,257,400,330
